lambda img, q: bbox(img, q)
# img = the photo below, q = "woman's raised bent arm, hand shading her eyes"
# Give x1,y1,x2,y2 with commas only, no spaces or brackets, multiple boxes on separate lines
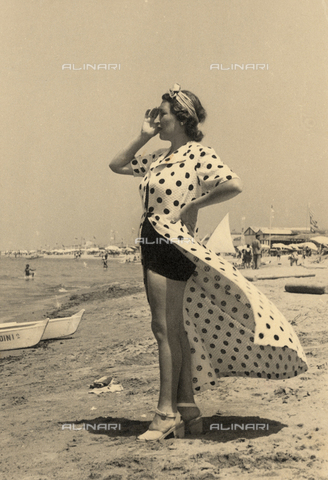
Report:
109,108,158,175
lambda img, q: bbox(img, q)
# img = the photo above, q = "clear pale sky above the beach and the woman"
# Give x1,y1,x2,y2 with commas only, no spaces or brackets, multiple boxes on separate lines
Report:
0,0,328,250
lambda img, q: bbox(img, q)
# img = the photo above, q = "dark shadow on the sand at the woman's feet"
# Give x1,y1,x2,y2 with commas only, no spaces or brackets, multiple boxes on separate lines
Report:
60,415,288,443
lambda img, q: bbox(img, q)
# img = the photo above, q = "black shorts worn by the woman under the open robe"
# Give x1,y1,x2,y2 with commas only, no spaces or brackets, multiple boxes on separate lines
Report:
141,217,196,282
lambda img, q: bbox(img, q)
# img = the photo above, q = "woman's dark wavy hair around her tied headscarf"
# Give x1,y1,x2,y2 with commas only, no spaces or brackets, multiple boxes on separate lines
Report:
162,90,206,142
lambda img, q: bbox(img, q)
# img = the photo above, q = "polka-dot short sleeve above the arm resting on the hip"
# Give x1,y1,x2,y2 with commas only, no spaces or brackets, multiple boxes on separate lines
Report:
196,147,239,193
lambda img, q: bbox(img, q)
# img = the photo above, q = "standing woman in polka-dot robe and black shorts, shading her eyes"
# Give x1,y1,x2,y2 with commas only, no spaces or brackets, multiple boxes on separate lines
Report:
110,84,306,440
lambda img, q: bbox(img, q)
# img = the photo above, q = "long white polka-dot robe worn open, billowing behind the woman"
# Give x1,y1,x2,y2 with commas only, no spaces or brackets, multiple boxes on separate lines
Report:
132,142,307,392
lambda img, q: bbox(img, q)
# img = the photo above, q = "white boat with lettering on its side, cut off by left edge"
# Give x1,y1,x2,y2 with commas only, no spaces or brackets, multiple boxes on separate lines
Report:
0,319,49,352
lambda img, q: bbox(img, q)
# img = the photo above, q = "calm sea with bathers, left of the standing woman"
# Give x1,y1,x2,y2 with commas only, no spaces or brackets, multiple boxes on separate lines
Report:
0,256,142,323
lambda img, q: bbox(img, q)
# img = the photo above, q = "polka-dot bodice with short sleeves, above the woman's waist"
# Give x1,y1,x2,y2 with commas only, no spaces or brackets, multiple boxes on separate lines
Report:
131,142,238,226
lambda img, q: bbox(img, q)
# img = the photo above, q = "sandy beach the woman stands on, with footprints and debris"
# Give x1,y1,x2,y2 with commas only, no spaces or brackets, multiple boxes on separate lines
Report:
0,258,328,480
